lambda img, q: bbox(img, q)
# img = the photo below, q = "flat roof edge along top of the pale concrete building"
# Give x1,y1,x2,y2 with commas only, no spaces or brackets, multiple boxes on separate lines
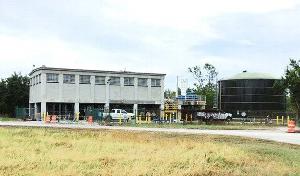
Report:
29,66,166,76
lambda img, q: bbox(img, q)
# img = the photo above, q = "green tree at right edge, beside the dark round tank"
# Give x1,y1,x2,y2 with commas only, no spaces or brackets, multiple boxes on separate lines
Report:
274,59,300,123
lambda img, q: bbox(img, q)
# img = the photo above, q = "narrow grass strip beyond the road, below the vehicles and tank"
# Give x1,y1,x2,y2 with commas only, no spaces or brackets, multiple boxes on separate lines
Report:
126,122,276,130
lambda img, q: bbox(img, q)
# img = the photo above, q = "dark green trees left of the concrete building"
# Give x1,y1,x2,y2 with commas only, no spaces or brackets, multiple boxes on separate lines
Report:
0,73,29,116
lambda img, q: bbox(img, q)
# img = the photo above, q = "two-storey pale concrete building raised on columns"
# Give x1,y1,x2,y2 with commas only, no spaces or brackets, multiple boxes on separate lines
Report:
29,66,165,119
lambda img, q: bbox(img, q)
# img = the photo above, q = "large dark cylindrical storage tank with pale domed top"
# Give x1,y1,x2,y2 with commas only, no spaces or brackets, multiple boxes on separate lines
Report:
218,71,286,115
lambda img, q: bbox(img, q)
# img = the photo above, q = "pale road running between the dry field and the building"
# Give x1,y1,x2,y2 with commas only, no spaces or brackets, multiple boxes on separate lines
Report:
0,121,300,145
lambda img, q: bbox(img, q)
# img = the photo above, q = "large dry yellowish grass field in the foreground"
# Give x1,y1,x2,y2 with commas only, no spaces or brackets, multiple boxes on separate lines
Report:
0,127,300,176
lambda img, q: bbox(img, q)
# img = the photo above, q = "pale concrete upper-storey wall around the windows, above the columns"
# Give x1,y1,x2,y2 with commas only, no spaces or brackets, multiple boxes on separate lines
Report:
29,70,164,106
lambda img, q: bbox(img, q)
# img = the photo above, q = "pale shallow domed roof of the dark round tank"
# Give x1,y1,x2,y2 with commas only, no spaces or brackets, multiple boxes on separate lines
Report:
220,71,279,81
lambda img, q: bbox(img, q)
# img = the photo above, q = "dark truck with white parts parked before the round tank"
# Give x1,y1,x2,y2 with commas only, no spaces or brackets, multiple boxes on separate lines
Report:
197,110,232,122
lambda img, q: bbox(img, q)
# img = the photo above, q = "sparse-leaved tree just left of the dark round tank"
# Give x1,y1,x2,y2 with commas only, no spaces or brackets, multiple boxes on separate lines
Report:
188,63,218,108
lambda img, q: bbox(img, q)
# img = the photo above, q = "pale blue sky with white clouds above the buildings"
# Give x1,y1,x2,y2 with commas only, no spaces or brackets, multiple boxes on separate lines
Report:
0,0,300,90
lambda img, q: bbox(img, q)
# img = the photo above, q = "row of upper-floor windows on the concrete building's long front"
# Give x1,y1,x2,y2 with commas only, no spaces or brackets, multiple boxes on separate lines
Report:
41,73,161,87
